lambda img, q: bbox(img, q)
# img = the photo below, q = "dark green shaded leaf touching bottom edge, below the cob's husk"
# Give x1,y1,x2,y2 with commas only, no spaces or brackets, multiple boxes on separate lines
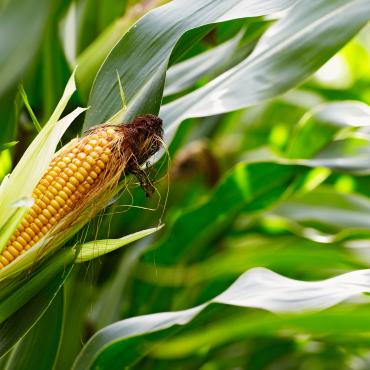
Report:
6,289,64,370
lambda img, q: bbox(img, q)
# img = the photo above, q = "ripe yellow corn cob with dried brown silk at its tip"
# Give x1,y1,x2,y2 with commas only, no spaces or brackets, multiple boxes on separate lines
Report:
0,115,162,269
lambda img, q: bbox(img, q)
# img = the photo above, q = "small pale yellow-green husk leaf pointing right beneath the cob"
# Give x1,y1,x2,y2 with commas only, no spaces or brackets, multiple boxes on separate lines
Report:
73,225,164,263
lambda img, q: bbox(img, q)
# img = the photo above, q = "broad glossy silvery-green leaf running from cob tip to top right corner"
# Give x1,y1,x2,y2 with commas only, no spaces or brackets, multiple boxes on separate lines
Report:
160,0,370,140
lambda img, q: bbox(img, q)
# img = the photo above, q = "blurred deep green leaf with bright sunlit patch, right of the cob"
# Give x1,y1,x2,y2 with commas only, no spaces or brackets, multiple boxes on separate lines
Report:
153,163,304,264
